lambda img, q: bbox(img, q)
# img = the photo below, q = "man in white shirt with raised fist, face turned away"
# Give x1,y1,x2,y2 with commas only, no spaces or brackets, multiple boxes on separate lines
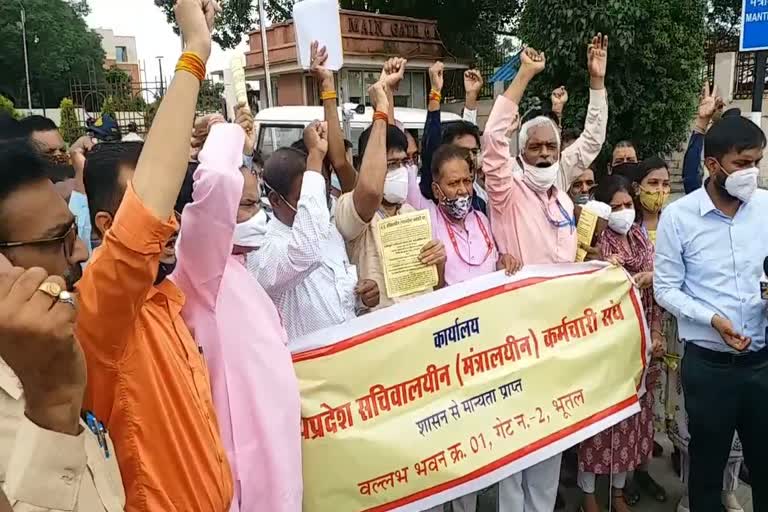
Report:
248,122,379,340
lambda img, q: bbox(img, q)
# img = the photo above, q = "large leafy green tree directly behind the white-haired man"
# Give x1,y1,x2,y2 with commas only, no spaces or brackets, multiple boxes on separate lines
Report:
520,0,706,156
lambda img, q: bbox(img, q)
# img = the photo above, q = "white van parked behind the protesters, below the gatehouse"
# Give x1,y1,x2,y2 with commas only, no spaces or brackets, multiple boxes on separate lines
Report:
256,103,461,159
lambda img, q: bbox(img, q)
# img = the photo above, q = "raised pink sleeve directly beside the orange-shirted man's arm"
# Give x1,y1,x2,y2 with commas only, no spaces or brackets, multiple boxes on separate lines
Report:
173,122,245,309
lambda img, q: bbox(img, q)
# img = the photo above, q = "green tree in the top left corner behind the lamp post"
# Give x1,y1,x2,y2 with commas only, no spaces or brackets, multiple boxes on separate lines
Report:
0,0,104,107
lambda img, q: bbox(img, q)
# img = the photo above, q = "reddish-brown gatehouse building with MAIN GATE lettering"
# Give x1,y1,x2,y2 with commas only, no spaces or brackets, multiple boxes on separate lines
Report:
246,10,467,108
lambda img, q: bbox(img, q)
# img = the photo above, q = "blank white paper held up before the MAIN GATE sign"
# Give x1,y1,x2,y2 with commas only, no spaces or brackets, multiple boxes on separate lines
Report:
293,0,344,71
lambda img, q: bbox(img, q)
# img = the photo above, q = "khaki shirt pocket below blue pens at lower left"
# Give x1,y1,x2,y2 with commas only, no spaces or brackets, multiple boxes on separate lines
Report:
85,432,125,512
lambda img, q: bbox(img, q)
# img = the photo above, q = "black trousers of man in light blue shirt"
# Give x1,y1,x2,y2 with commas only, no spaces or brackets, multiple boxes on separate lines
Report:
681,343,768,512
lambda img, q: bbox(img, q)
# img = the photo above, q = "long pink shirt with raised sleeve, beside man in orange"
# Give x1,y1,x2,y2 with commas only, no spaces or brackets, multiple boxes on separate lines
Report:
172,124,302,512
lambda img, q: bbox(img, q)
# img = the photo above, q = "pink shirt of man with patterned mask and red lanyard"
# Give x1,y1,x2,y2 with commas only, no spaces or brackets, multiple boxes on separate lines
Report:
408,167,499,286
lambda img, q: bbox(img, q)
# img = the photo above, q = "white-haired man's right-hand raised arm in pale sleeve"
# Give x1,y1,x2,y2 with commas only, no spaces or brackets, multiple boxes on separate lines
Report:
560,34,608,190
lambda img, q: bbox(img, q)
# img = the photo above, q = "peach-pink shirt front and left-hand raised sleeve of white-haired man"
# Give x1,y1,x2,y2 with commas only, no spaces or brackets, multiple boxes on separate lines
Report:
483,96,577,265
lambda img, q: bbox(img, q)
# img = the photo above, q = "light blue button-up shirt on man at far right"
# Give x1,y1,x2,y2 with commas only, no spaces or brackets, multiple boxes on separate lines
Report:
653,186,768,352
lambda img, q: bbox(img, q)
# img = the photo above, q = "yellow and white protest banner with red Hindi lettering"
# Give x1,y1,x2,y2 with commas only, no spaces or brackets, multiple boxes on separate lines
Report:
294,264,649,512
